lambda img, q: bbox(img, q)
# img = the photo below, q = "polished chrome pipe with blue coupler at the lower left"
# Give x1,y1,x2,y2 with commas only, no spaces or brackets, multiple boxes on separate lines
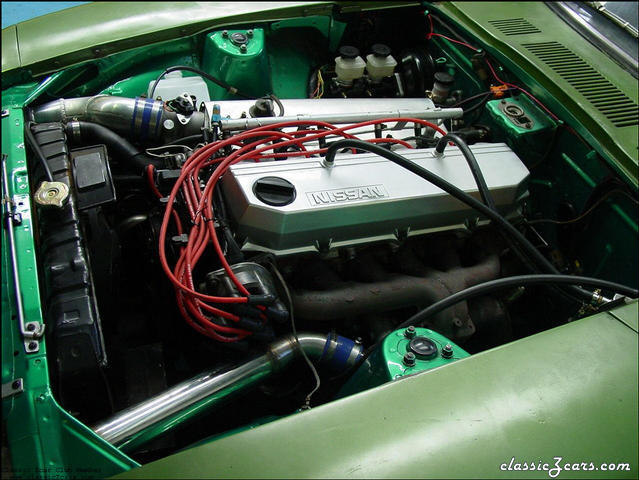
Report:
92,333,362,450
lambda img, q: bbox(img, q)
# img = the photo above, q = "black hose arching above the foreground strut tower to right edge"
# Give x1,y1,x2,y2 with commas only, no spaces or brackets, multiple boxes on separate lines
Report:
396,274,639,329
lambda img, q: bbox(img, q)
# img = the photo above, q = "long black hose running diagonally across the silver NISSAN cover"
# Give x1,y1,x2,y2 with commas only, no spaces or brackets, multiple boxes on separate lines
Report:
326,139,593,302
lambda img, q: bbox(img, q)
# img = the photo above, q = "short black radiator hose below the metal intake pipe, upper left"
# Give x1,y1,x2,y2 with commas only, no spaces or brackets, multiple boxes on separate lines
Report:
66,122,162,173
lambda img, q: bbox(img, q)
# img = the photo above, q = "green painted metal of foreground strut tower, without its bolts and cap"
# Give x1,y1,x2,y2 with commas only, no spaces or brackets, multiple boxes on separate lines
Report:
337,327,470,398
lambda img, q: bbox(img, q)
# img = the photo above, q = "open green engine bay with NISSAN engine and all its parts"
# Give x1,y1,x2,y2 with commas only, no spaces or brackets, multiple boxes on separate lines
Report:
8,2,638,463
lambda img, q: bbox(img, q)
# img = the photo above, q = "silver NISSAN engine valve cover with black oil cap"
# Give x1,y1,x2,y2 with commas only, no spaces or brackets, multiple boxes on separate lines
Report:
223,143,528,250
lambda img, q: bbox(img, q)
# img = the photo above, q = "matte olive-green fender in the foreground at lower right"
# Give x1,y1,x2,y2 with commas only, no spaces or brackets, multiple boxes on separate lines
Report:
116,301,639,478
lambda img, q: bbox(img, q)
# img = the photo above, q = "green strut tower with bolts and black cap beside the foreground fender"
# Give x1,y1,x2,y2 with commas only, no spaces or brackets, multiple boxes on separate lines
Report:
337,327,470,398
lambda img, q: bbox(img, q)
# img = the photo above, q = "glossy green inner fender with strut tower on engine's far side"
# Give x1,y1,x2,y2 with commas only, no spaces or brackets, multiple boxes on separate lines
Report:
99,16,346,100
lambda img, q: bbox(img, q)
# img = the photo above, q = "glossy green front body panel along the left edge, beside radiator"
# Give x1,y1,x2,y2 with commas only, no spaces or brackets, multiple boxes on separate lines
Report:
2,109,139,478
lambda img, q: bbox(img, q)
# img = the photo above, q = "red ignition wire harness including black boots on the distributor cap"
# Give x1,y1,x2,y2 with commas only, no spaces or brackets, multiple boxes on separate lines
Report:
152,118,446,342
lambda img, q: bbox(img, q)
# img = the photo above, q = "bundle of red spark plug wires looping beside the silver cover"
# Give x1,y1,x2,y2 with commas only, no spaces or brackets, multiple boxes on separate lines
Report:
159,118,446,342
